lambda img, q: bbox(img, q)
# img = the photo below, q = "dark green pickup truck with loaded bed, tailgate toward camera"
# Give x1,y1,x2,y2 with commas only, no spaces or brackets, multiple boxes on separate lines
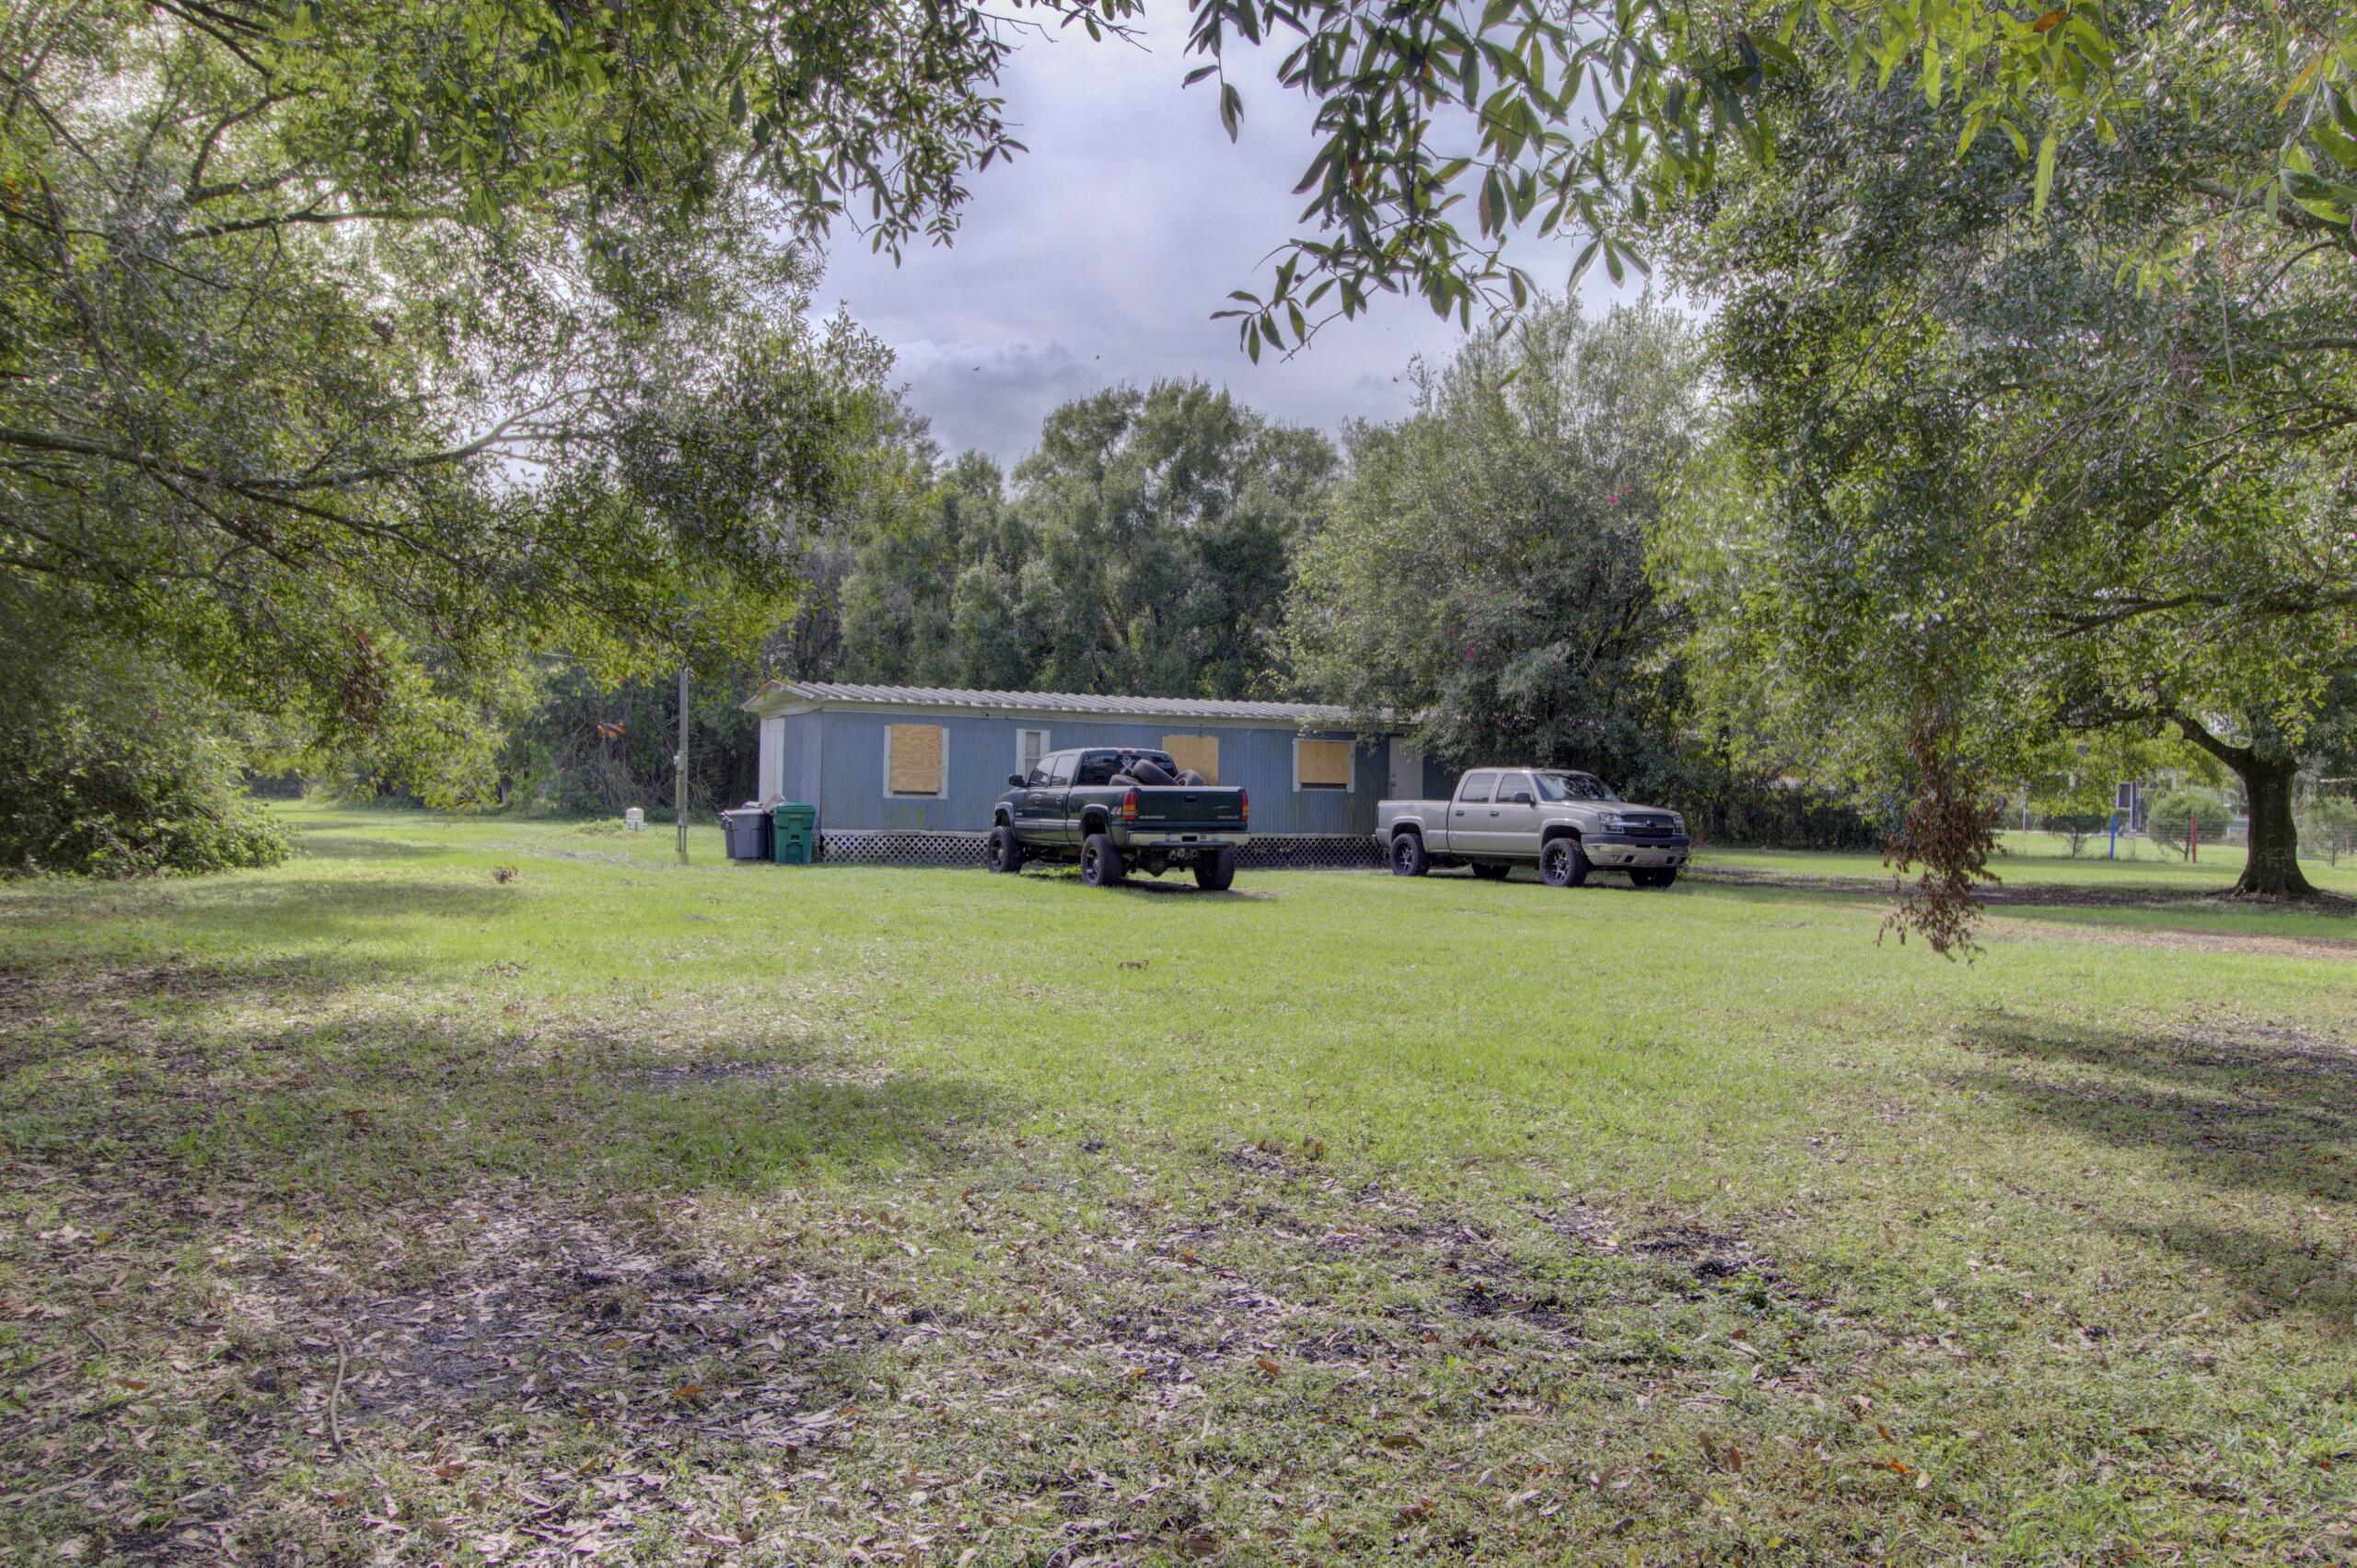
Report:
985,748,1251,894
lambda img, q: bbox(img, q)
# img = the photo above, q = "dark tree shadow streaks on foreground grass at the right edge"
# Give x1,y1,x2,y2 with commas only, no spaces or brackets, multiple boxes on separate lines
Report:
1961,1018,2357,1328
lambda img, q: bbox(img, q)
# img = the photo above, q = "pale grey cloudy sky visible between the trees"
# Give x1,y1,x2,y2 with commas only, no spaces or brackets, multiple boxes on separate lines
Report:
818,0,1609,462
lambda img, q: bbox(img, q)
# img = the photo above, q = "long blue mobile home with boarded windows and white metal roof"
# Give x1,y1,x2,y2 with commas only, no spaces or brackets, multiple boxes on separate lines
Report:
745,681,1449,863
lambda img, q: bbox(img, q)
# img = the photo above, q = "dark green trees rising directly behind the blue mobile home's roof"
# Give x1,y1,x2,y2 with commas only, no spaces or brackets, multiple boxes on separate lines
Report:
843,382,1334,698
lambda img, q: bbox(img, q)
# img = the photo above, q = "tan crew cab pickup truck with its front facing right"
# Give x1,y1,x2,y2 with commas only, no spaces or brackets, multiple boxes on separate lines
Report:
1374,769,1692,887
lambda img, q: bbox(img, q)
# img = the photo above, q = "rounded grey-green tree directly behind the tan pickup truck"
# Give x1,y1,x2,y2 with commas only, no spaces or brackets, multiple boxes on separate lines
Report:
1287,302,1704,785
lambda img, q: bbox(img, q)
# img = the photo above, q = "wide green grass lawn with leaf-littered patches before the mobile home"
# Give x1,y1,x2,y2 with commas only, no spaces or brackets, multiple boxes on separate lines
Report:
0,807,2357,1565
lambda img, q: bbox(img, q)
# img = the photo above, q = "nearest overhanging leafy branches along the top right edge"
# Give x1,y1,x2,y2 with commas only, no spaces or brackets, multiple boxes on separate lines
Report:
1188,0,2357,358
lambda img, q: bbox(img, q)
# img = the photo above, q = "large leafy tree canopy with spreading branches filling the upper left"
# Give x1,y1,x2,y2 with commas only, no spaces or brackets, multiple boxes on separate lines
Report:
0,0,928,830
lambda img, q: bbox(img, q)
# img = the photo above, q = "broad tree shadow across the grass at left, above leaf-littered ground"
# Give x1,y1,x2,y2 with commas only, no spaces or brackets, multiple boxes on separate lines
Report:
0,958,1020,1205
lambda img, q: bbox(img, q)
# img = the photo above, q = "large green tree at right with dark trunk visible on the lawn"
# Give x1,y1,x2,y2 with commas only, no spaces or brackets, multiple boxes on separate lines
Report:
1668,30,2357,894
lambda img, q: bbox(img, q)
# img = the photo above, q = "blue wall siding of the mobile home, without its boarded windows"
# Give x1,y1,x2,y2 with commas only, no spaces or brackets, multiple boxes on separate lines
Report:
783,707,1390,835
